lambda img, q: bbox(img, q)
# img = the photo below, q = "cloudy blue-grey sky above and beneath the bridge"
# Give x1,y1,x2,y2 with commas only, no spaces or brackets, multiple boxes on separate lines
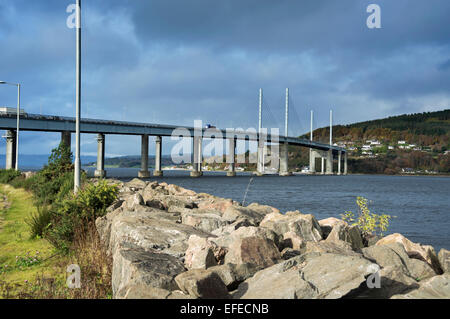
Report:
0,0,450,156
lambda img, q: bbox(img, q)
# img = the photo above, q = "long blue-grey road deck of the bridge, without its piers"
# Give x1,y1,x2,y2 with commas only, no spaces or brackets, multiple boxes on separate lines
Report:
0,113,346,153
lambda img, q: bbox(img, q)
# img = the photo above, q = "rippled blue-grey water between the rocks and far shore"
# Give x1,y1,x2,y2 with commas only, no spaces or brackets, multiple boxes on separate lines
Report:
88,169,450,250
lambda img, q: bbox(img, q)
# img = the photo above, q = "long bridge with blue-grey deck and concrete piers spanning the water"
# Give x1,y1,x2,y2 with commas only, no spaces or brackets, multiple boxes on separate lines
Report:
0,112,347,178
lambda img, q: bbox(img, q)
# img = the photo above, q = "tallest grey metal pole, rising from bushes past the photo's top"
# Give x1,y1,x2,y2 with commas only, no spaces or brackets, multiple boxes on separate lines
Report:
74,0,81,193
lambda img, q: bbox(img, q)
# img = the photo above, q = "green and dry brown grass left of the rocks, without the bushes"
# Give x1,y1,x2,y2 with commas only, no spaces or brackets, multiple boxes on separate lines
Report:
0,184,111,299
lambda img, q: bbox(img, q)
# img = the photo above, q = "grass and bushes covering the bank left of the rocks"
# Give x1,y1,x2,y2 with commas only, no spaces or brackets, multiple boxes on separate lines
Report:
0,144,118,298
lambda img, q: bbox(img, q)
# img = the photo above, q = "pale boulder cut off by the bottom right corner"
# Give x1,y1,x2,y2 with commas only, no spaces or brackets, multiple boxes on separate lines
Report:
392,273,450,299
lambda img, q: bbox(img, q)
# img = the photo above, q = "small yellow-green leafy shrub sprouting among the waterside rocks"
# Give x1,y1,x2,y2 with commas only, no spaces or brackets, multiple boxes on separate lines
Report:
341,196,395,236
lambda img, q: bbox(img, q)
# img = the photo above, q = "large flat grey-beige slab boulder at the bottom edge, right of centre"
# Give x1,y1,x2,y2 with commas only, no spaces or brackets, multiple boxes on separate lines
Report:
233,253,372,299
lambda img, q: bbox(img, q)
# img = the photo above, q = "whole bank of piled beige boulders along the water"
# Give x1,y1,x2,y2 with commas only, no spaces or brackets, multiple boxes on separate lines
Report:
96,179,450,299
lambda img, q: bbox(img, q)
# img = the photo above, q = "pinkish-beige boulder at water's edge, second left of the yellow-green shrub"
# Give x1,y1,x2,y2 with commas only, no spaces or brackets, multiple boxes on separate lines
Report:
260,211,322,241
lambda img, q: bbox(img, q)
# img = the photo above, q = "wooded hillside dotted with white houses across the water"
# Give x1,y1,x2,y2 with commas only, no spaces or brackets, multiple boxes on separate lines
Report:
296,110,450,174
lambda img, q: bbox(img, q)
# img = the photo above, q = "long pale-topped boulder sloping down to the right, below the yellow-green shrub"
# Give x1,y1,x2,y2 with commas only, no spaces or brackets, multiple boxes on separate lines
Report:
375,233,442,274
